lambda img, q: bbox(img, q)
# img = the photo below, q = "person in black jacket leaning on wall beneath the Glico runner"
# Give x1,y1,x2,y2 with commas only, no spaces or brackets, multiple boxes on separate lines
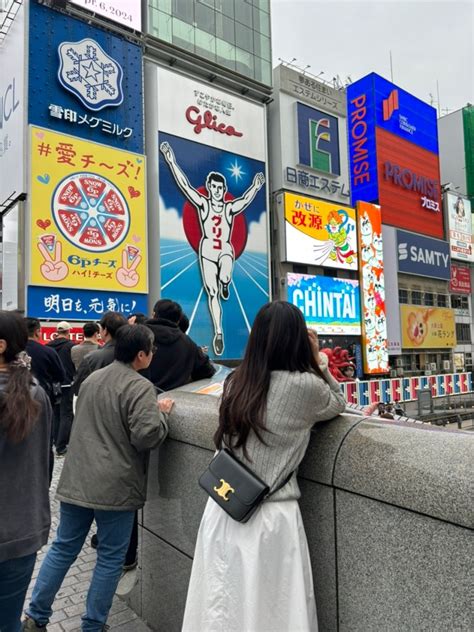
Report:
145,299,215,391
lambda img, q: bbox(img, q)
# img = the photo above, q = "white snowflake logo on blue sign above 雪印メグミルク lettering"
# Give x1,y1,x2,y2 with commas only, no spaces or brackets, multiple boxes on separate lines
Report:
58,39,123,112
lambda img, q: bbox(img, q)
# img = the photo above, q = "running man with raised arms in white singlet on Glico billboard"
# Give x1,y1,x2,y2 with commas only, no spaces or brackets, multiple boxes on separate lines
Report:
160,142,265,356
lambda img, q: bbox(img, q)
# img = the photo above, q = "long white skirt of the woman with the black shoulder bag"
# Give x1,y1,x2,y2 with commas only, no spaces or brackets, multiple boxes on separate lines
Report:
182,499,318,632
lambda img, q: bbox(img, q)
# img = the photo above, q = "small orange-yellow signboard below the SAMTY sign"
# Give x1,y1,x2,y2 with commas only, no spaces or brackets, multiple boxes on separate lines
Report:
400,305,456,349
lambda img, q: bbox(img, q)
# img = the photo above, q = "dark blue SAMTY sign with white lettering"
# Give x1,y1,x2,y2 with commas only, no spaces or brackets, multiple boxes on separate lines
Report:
397,230,451,281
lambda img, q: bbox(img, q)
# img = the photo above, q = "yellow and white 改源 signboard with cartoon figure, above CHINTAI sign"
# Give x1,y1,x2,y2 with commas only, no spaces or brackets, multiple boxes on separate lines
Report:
284,193,357,270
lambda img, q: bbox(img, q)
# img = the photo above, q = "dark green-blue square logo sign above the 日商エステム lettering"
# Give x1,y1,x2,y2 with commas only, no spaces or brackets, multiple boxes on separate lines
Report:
297,103,341,175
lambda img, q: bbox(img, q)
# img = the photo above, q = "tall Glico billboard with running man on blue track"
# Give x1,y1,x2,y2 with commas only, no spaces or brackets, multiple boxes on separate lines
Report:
156,69,269,358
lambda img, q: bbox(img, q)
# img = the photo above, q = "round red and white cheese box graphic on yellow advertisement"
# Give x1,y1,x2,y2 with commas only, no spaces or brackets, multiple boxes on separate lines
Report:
52,173,130,252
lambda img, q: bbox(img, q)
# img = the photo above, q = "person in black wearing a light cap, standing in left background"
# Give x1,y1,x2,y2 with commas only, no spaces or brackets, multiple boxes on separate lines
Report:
46,320,76,456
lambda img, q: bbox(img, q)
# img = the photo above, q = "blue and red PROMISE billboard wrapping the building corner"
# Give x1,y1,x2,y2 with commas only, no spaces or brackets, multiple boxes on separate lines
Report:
347,73,444,238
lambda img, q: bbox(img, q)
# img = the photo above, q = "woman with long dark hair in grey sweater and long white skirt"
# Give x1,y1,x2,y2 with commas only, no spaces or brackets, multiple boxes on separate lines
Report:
183,301,345,632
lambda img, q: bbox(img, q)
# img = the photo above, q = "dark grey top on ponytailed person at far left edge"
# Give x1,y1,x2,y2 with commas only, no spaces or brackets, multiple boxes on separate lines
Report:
0,373,52,562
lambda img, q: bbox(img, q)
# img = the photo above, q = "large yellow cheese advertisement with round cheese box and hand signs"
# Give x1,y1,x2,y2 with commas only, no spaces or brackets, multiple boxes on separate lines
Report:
30,127,148,293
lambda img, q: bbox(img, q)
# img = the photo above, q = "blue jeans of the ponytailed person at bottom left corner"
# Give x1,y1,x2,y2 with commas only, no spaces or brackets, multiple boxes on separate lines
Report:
0,553,36,632
